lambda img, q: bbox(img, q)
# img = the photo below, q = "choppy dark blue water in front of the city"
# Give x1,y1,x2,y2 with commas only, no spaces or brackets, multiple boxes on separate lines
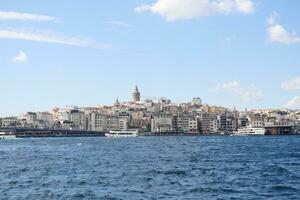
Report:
0,136,300,199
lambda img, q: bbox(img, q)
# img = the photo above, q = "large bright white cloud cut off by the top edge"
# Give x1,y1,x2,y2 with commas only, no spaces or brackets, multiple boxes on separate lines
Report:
135,0,255,21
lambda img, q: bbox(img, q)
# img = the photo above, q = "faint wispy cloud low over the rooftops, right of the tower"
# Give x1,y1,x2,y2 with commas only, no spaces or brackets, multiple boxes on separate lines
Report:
215,80,263,102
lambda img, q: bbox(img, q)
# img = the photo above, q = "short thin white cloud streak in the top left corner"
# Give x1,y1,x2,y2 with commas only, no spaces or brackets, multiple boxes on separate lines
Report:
0,11,56,21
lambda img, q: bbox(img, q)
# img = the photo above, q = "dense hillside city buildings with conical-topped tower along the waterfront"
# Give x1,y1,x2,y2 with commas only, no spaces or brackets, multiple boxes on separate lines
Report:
0,86,300,135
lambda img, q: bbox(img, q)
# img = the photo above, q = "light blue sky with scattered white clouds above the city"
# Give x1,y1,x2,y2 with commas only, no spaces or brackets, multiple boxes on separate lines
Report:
0,0,300,117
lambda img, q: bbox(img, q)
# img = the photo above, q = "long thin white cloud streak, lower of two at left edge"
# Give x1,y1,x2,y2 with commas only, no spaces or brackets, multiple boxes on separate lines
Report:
0,29,111,49
